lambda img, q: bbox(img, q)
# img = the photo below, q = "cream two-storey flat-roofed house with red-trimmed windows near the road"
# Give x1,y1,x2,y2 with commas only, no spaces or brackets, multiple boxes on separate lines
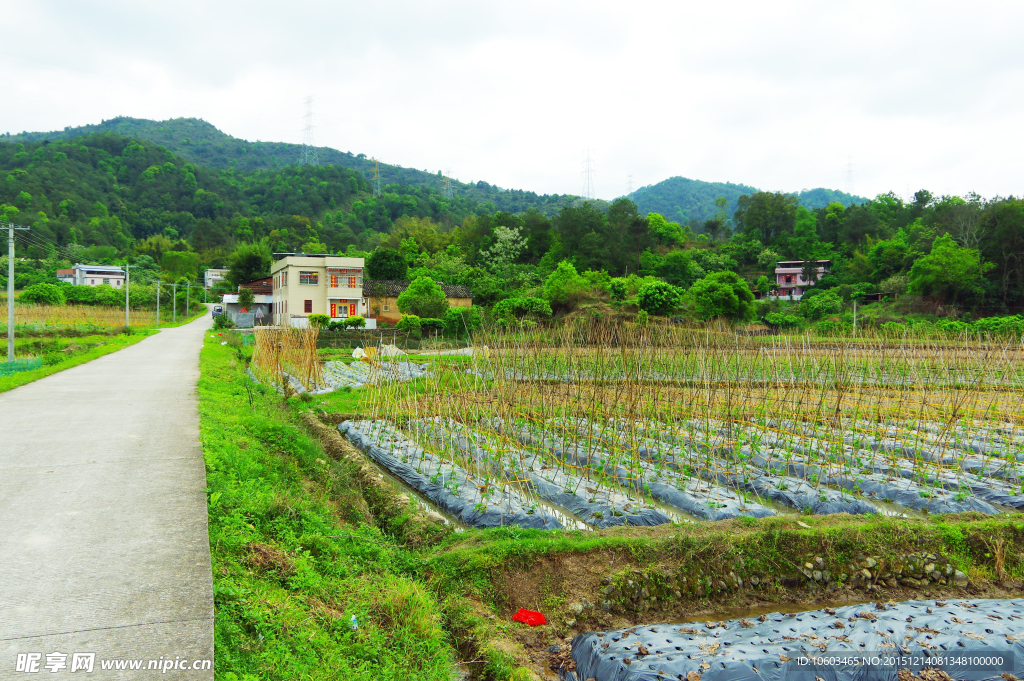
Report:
270,253,370,327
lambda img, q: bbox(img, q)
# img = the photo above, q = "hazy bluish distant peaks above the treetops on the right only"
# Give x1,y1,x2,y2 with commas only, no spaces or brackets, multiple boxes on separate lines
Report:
629,176,867,223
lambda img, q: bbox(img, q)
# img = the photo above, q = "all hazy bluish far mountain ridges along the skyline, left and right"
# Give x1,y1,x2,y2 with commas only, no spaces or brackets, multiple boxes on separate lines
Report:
9,116,867,222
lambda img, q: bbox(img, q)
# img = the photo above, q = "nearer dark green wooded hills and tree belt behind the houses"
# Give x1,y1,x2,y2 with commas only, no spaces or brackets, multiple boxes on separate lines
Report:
0,124,1024,313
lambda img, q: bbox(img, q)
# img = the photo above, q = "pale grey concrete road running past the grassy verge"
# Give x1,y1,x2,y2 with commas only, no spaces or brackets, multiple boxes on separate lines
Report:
0,316,213,680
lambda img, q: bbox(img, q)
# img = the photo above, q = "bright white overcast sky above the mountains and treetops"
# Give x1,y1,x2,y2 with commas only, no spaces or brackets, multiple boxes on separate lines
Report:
0,0,1024,199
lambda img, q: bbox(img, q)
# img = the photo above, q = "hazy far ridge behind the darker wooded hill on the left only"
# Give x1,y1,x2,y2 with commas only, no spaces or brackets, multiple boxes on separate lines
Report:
0,117,579,215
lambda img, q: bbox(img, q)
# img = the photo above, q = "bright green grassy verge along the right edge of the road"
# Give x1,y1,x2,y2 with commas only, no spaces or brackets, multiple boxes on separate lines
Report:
199,334,456,681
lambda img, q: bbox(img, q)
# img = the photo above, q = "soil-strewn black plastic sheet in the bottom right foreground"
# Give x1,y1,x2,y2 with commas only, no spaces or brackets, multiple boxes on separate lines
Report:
560,600,1024,681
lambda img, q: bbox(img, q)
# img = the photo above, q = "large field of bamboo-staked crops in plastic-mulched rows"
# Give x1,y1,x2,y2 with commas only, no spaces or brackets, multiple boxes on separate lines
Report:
350,321,1024,527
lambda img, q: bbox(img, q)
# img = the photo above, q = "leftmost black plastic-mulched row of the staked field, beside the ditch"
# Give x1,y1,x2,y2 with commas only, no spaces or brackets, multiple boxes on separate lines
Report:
338,421,563,529
